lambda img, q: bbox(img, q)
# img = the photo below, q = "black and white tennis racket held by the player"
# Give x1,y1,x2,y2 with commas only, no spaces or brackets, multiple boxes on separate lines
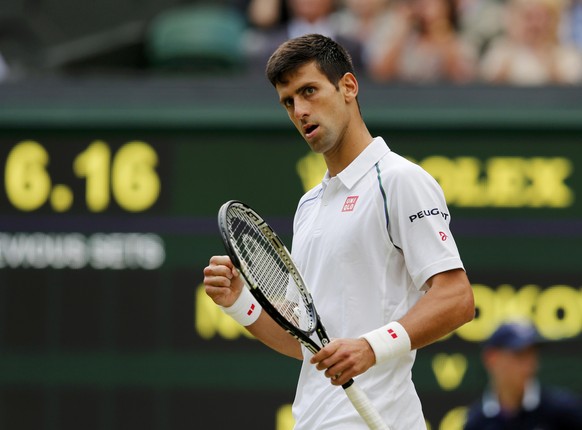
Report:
218,200,389,430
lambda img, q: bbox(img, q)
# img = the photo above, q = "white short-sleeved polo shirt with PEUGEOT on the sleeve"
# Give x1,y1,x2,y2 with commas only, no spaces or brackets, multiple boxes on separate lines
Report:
292,137,463,430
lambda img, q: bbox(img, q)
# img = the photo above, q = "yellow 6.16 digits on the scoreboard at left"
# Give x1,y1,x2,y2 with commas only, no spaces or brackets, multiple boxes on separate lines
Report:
4,140,161,212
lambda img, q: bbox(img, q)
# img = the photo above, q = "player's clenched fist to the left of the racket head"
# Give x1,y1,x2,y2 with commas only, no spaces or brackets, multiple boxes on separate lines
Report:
204,255,244,308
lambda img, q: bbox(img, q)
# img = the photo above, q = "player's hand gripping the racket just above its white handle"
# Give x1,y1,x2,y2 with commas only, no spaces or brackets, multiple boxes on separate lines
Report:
310,339,376,385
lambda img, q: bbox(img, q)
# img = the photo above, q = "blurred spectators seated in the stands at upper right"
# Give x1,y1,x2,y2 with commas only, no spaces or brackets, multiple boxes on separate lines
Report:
232,0,582,86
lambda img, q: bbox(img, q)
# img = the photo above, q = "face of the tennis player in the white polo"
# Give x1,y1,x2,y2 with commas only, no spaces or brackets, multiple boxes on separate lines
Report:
276,62,351,154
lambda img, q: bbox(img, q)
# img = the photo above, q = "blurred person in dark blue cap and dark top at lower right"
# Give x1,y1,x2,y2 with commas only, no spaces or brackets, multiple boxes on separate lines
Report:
464,320,582,430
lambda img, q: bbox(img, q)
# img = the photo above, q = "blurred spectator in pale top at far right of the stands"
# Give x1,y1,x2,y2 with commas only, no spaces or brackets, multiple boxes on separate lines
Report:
481,0,582,85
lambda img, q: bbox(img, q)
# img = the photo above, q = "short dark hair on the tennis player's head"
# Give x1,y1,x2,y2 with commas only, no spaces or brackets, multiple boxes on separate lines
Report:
266,34,354,88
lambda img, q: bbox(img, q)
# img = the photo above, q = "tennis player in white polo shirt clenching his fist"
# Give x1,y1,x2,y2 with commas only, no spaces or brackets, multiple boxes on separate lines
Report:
204,34,474,430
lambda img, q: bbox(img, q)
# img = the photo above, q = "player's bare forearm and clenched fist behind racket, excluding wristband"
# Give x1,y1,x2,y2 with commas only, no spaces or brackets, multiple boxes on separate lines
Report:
204,256,303,360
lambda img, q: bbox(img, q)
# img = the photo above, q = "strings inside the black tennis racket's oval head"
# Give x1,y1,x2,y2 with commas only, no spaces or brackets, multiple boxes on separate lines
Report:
227,207,315,332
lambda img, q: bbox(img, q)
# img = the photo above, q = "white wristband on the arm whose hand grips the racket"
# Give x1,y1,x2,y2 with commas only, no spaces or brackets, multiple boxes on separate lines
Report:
362,321,410,364
